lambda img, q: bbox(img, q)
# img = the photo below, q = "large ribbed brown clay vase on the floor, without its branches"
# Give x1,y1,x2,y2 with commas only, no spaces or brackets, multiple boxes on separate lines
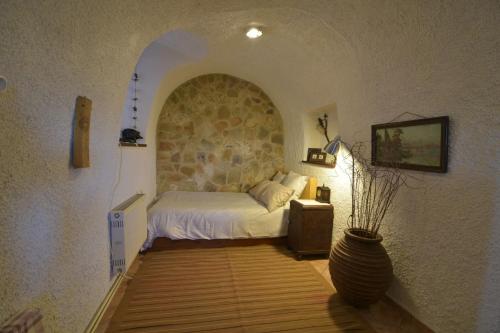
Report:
329,229,392,307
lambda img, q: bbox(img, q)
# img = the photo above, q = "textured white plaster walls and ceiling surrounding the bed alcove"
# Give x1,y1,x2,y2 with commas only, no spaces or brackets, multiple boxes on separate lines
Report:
0,0,500,332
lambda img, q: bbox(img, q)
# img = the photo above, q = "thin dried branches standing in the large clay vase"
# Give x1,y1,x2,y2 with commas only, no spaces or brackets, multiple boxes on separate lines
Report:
344,142,406,238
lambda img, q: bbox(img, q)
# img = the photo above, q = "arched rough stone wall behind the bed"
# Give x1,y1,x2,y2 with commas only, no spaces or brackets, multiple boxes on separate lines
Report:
157,74,283,193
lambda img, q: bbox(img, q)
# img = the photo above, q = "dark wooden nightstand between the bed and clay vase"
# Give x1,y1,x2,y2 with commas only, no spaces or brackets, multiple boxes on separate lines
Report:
288,200,333,259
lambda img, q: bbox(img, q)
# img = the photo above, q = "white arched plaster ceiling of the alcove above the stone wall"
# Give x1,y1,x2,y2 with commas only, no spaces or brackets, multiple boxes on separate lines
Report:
122,7,364,141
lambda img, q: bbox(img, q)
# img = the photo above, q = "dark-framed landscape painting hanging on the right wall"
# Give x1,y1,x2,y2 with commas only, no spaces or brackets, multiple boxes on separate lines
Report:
372,117,449,172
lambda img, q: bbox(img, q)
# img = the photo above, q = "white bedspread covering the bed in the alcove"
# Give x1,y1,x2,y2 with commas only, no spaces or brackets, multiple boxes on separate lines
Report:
143,191,290,249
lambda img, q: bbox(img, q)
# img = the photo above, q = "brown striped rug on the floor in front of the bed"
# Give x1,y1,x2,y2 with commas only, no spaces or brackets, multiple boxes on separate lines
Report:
108,245,373,333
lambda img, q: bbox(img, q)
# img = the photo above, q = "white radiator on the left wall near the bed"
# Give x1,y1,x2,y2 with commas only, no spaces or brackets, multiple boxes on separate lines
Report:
109,194,147,275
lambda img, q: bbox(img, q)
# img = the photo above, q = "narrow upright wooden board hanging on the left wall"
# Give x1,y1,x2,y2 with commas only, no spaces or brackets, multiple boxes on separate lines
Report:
73,96,92,168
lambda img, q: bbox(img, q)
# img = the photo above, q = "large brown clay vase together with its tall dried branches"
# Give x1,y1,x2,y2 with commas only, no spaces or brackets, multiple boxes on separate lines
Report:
324,136,406,306
